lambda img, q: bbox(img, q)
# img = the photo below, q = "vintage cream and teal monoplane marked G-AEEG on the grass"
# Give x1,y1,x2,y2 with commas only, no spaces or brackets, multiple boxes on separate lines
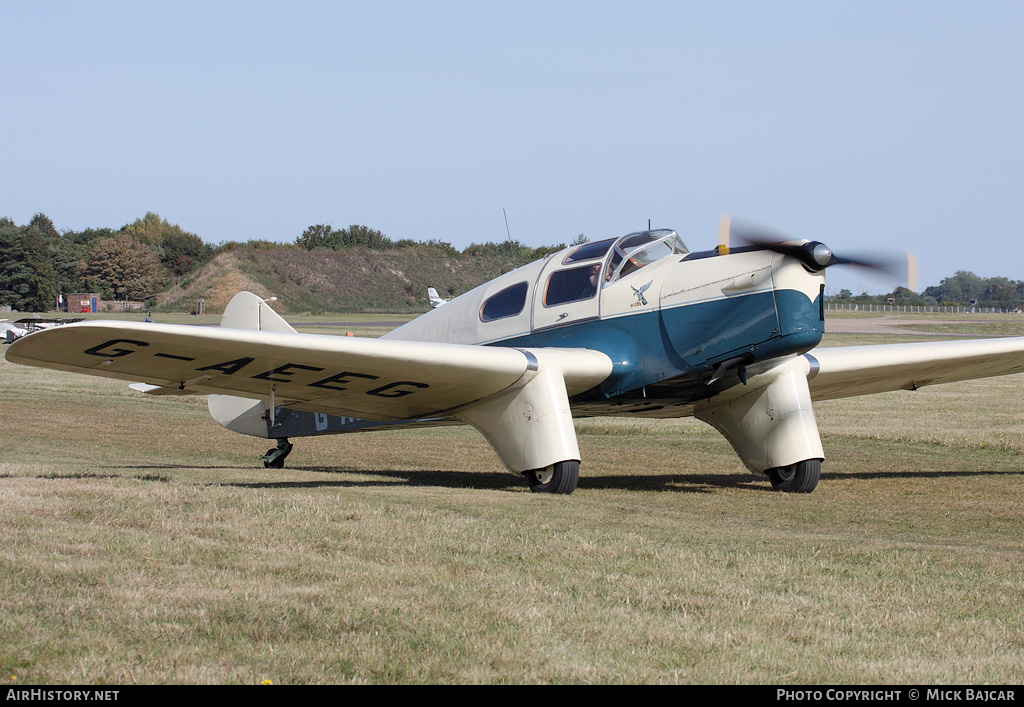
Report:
6,219,1024,494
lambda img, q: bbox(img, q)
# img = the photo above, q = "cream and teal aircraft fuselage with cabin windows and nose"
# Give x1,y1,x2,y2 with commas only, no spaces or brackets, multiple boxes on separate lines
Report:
385,231,824,416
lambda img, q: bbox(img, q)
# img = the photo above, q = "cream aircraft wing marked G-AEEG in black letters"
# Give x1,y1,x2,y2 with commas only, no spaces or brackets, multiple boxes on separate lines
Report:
6,322,611,420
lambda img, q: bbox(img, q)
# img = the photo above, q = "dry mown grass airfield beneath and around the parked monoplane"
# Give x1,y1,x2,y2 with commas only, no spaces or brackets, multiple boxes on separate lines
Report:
0,315,1024,684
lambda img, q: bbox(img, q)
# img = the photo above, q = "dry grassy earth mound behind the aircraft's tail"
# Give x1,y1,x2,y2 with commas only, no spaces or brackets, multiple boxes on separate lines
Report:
157,244,524,314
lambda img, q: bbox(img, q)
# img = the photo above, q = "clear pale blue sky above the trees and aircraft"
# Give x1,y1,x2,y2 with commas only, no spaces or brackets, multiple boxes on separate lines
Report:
0,0,1024,291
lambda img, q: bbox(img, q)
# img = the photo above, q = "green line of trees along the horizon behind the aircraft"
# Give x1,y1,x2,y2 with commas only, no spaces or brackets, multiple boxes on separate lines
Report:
12,212,1024,311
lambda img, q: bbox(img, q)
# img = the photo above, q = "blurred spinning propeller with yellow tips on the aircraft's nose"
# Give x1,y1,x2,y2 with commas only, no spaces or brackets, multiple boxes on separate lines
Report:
719,216,918,292
